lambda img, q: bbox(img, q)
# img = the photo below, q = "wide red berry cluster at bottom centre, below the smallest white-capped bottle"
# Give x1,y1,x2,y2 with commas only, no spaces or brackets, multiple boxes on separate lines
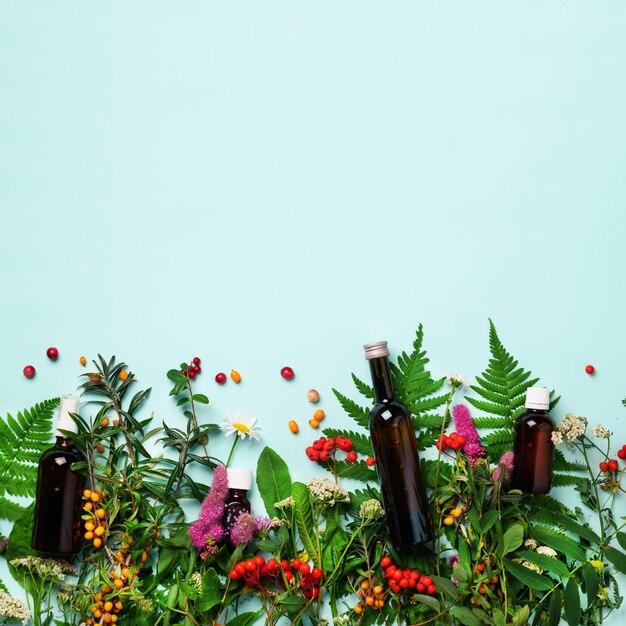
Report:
230,555,324,598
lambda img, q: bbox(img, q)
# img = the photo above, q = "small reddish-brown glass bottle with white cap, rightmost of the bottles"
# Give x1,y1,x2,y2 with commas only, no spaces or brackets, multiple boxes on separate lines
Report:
511,387,555,493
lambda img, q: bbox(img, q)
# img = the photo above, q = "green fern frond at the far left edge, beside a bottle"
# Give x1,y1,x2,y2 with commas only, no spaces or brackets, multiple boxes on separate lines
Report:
0,398,59,521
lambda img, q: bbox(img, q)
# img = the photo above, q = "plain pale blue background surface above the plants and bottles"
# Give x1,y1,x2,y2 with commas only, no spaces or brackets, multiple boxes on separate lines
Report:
0,1,626,624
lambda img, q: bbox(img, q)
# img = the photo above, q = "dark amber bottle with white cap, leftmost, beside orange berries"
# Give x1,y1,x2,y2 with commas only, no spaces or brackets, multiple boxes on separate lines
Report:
32,396,86,557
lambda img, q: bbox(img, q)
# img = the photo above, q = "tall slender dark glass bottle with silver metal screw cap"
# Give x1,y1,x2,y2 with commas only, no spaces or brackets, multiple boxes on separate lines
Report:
364,341,432,549
